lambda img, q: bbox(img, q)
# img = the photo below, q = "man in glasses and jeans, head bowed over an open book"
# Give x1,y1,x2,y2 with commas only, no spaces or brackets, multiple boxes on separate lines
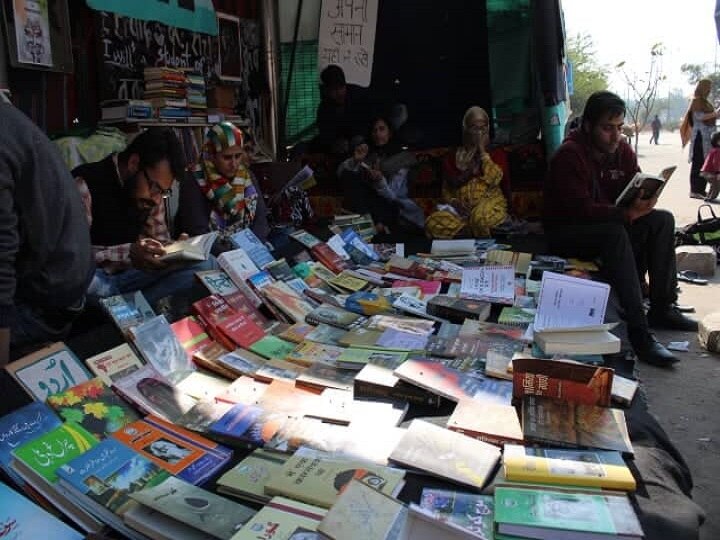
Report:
73,128,211,305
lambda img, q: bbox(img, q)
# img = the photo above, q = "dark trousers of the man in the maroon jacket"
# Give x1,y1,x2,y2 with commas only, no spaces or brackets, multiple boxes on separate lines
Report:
546,210,677,337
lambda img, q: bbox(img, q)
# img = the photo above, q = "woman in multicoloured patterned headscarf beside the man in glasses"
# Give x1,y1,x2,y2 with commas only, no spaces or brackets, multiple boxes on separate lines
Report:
188,122,269,245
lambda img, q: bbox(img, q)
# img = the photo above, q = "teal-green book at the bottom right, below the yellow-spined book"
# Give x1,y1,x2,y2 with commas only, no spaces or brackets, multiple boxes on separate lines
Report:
495,486,643,540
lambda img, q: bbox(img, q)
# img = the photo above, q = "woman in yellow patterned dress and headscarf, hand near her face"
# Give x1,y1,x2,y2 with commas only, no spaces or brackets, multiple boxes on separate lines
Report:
425,107,508,238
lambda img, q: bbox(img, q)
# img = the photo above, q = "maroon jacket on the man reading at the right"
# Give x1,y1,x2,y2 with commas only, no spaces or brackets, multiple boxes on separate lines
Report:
544,129,640,225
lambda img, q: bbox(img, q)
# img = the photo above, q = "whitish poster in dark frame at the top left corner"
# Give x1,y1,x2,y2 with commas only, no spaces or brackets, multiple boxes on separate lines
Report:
13,0,52,67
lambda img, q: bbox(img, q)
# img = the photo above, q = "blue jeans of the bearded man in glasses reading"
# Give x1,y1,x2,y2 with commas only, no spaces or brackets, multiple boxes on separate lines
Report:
87,257,218,306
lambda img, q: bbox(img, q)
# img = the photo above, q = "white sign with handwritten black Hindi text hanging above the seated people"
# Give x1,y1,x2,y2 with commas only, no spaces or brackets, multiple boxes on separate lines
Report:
318,0,378,87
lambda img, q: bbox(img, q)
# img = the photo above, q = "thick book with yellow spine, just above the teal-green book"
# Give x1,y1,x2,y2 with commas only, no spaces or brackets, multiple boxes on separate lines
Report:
503,444,636,491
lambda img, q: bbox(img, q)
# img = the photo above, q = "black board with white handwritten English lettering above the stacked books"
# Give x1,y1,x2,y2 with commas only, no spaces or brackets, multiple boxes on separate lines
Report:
98,11,218,100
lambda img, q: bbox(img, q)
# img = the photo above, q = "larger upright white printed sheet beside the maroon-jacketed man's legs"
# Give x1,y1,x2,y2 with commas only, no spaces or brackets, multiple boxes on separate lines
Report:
533,272,610,331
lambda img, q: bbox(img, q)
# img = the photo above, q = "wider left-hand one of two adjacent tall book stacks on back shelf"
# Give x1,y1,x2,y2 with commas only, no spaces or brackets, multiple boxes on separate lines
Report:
143,67,191,121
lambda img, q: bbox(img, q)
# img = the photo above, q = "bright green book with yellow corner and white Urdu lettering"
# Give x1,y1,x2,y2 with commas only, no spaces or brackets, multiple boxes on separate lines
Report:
13,422,98,484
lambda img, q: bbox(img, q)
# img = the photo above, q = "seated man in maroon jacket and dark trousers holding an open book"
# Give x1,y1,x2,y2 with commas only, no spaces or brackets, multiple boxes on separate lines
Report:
544,92,697,366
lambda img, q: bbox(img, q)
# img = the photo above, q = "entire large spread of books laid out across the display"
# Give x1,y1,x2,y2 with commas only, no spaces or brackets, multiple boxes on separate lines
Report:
0,240,642,540
